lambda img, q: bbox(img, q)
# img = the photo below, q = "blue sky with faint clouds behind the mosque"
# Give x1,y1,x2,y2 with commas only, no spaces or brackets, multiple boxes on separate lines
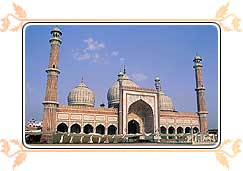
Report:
25,24,218,128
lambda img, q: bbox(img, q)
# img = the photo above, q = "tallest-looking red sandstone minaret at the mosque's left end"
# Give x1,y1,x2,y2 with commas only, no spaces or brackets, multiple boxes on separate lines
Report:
41,27,62,143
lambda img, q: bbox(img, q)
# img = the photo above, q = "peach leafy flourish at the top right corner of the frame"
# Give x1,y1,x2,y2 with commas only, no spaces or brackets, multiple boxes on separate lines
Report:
216,2,242,32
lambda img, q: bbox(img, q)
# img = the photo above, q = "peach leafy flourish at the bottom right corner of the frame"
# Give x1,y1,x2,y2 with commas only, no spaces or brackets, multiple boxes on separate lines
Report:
215,139,241,170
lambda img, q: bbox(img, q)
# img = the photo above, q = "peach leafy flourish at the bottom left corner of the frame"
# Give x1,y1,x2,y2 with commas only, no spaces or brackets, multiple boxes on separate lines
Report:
0,139,27,170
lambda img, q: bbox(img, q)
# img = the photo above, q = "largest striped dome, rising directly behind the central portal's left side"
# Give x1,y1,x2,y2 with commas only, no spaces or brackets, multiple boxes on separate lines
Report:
107,72,139,107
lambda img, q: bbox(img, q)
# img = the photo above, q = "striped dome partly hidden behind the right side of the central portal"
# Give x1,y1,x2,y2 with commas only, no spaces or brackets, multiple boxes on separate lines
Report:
159,91,175,111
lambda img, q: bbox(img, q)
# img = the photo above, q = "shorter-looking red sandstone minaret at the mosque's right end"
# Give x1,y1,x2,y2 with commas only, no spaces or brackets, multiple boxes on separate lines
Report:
193,54,208,134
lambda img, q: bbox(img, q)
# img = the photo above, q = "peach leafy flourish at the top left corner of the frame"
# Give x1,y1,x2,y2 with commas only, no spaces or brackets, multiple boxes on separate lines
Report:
0,3,27,32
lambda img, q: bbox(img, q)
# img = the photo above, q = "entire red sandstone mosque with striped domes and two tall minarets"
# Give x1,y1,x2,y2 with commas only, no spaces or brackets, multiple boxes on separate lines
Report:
41,27,208,143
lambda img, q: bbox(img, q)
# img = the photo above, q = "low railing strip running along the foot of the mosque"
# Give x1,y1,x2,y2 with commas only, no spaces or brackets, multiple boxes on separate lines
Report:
52,133,218,144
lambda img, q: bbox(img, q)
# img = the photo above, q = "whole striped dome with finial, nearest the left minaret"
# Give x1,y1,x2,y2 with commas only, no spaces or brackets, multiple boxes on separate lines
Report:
68,81,95,107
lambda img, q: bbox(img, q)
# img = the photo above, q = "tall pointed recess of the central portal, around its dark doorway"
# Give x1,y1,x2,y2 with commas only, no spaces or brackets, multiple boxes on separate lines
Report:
128,99,154,133
